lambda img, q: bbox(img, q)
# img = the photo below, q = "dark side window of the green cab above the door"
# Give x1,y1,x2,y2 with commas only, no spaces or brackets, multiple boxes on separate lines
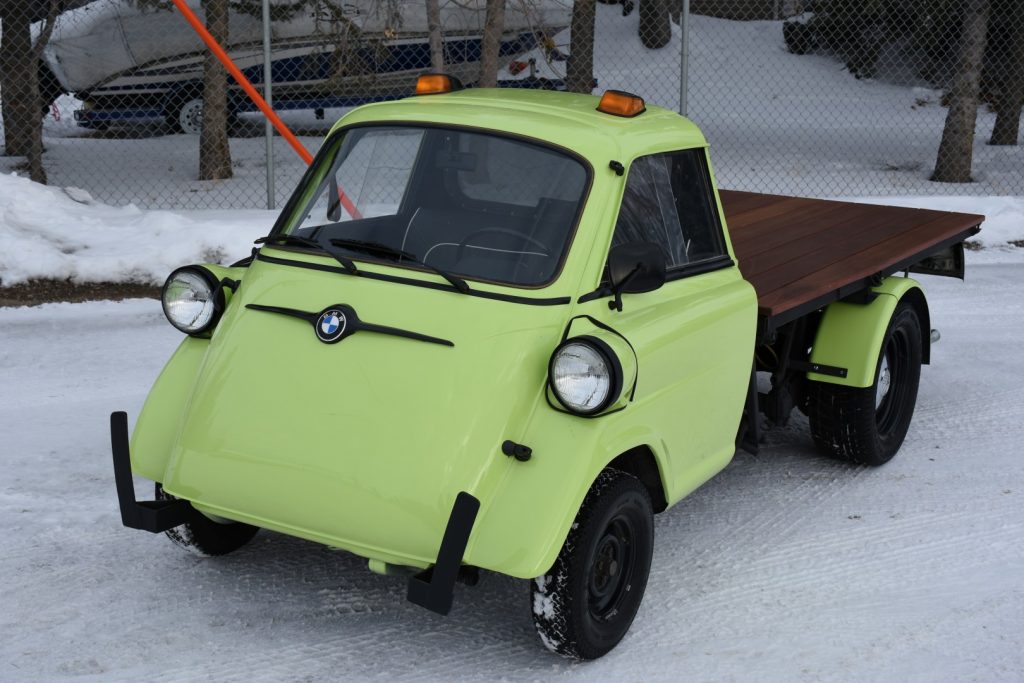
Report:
611,150,725,270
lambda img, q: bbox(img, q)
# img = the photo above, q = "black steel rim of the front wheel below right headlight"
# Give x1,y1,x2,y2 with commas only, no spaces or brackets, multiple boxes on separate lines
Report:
587,514,637,621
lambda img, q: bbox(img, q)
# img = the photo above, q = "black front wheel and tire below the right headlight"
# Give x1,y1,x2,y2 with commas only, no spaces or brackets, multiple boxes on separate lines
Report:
530,470,654,659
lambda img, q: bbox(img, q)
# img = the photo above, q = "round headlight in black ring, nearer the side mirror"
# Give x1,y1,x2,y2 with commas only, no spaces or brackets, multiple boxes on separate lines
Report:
549,337,623,415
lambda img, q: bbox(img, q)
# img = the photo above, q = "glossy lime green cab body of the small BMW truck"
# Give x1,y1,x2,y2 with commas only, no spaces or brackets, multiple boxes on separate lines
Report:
132,90,757,578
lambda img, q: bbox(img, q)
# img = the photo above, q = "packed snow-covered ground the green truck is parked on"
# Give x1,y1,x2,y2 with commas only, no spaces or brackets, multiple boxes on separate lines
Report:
0,253,1024,682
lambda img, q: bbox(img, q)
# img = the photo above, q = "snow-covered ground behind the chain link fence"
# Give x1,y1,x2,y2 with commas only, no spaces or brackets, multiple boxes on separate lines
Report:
0,5,1024,208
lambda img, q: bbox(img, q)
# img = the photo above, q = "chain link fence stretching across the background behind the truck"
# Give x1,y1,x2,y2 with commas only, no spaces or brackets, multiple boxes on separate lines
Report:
0,0,1024,209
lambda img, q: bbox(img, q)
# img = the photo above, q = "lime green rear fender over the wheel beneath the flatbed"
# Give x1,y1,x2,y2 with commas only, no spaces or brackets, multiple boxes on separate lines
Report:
807,278,931,388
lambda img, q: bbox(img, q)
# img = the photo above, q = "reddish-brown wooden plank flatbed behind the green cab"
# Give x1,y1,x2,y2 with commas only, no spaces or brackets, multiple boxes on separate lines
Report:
720,189,985,332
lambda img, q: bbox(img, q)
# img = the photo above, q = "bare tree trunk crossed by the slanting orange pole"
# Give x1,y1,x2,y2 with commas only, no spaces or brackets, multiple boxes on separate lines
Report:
199,0,231,180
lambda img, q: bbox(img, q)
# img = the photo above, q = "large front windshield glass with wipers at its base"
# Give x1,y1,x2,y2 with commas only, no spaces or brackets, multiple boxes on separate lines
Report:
284,126,588,287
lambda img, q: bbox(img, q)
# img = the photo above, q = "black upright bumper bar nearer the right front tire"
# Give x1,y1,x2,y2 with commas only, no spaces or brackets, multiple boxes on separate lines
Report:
408,490,480,614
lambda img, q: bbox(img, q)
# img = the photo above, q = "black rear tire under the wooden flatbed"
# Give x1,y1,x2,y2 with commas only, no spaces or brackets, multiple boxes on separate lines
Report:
808,299,923,467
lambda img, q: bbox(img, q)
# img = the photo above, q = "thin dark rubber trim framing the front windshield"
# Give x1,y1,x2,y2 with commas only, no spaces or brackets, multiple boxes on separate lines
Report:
269,120,594,290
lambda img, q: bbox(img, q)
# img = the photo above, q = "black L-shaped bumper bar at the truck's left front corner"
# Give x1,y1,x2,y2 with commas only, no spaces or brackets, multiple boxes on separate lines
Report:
111,411,195,533
